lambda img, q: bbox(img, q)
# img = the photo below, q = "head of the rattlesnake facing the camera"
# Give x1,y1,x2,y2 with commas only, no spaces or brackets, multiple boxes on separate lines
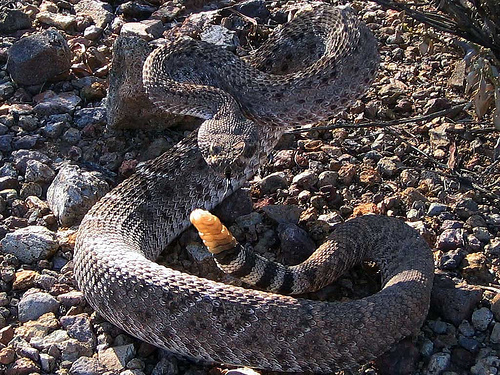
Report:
198,118,259,180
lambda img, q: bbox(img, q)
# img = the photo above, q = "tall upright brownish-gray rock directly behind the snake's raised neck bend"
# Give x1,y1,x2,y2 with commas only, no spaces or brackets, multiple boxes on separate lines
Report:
106,36,183,129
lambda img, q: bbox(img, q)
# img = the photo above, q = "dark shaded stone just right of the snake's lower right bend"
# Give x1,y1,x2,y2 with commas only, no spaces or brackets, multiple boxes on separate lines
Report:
431,273,483,326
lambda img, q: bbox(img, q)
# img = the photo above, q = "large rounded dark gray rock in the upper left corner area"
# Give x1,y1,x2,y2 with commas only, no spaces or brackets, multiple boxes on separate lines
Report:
7,29,71,85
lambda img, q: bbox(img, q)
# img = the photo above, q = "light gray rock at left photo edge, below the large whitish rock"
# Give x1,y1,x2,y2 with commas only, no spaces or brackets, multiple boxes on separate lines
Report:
0,225,59,263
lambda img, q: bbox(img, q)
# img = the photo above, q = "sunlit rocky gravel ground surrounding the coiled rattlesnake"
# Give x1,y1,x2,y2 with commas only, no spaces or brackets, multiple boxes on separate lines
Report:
0,0,500,375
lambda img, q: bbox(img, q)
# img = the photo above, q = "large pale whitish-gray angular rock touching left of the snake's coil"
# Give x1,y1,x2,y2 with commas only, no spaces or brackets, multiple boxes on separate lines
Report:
47,164,109,226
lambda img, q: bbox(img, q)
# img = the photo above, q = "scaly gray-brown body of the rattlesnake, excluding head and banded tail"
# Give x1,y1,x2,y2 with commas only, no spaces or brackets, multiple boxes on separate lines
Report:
74,4,433,373
